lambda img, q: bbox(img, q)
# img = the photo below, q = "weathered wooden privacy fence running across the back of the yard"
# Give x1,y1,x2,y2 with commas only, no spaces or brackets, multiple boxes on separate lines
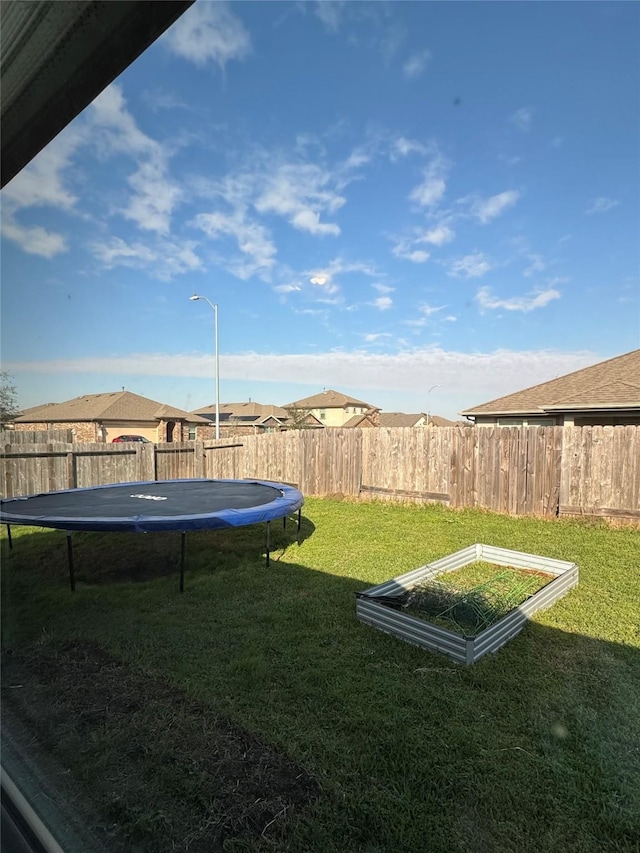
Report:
0,426,640,521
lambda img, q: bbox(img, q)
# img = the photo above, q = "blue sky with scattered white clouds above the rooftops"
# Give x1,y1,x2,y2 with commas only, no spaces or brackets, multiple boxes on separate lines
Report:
1,0,640,418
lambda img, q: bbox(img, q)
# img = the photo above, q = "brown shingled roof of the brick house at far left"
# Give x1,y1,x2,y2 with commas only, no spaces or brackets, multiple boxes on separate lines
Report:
14,391,208,424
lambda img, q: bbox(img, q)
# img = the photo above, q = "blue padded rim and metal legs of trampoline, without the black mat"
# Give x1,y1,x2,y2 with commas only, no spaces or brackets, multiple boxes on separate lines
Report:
0,477,304,592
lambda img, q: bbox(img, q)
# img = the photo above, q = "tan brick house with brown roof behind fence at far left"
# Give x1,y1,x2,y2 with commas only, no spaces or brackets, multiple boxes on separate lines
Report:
13,391,209,442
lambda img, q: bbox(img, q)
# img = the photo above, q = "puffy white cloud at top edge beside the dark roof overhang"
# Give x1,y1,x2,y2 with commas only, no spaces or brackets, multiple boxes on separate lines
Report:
162,0,251,70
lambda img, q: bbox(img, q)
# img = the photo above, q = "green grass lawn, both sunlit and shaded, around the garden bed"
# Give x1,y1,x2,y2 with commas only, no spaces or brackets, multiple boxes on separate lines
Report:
2,499,640,853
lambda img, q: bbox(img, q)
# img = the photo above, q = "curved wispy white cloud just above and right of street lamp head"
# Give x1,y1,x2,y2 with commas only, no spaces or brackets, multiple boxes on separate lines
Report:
193,207,276,279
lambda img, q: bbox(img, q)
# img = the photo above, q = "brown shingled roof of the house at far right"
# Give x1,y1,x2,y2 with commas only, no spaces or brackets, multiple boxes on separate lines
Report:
460,349,640,417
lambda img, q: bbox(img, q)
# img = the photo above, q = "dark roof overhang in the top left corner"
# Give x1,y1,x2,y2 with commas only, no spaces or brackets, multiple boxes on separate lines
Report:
0,0,194,186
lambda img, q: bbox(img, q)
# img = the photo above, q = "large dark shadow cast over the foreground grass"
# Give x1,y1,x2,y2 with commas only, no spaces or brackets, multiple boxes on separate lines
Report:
3,528,640,853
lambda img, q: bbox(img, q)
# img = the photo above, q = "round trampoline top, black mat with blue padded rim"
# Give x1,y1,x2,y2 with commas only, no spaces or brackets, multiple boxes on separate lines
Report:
0,479,304,533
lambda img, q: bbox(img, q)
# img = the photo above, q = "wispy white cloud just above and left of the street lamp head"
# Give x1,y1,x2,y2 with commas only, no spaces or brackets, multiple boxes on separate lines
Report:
89,237,203,281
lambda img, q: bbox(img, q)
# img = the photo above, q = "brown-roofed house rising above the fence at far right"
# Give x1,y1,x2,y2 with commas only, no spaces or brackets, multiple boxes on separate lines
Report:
460,349,640,426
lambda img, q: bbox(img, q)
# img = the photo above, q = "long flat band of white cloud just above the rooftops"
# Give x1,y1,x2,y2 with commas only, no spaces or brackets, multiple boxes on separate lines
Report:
10,348,603,411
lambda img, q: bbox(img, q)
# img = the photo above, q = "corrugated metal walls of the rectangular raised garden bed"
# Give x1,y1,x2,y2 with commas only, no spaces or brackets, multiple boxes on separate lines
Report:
356,544,578,665
